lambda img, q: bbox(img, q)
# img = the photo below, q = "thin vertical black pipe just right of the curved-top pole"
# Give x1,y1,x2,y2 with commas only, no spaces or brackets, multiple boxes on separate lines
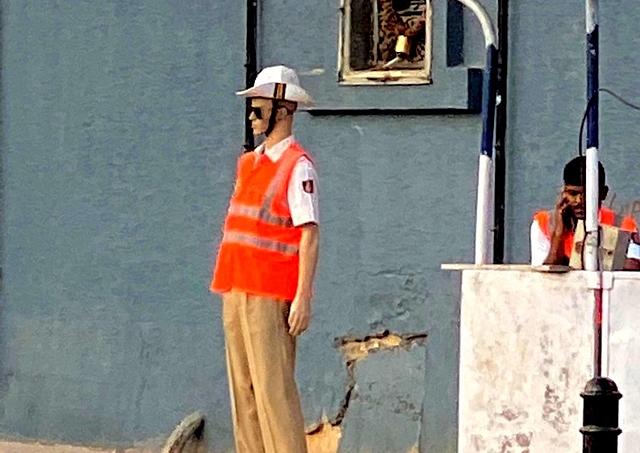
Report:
493,0,509,264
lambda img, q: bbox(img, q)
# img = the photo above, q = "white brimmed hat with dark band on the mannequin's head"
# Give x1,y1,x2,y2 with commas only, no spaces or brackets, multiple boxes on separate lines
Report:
236,66,313,105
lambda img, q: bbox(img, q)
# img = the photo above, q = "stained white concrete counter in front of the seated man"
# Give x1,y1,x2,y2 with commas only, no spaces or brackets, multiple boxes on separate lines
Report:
450,266,640,453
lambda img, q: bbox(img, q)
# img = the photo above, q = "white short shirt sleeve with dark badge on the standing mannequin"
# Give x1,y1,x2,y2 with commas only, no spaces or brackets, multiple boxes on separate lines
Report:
287,157,319,226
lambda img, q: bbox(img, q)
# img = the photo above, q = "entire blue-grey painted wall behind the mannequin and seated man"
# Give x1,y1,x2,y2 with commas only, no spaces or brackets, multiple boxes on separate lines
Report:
0,0,640,453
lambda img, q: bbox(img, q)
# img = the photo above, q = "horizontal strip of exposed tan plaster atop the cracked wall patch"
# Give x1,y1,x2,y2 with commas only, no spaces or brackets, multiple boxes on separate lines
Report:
336,330,427,360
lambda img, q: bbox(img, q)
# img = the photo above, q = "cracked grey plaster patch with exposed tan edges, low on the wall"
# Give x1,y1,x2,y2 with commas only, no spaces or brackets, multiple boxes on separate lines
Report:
307,331,427,453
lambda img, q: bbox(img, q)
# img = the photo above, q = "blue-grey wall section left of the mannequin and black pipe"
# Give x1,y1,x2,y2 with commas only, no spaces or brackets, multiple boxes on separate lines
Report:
0,0,244,449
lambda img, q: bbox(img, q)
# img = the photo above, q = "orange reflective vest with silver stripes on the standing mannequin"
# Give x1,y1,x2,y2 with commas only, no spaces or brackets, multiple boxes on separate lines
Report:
210,143,311,301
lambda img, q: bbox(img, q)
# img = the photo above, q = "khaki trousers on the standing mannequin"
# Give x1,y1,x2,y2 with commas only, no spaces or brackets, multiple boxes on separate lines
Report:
222,292,307,453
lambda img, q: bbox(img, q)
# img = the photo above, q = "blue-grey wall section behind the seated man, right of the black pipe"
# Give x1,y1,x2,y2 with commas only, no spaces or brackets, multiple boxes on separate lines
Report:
506,0,640,262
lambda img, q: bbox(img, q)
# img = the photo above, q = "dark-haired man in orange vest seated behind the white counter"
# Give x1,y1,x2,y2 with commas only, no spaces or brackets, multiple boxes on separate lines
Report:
531,156,640,269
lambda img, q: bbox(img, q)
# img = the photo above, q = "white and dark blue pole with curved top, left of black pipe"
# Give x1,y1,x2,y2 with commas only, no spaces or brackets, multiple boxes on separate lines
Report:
458,0,498,264
